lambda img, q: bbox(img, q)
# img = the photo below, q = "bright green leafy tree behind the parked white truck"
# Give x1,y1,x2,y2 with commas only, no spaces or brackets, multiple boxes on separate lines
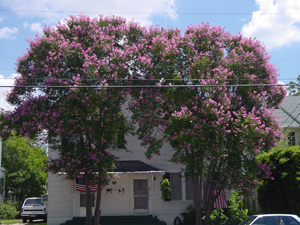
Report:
2,135,48,206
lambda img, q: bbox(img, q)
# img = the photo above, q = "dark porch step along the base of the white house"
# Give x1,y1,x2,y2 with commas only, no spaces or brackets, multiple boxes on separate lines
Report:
60,216,167,225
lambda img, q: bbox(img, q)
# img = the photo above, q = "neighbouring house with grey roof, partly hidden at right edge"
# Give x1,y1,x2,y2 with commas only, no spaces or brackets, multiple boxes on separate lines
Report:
273,95,300,146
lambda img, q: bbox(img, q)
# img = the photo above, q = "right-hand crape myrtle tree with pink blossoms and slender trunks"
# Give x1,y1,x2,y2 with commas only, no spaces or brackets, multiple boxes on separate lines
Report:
130,23,285,225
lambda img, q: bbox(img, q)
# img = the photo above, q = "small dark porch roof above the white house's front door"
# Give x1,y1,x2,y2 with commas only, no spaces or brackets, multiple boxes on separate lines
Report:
114,160,164,173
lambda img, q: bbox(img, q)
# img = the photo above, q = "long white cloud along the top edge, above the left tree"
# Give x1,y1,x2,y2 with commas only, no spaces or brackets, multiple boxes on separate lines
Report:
2,0,177,25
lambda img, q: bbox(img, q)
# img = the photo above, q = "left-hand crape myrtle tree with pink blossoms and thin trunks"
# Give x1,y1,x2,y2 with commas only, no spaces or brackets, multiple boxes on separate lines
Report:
3,16,141,225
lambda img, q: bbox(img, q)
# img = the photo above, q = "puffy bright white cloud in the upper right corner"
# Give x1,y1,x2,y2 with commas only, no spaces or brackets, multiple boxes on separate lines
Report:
242,0,300,50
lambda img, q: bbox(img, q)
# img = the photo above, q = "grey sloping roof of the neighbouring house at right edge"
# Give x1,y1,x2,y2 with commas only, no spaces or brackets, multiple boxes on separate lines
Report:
273,96,300,128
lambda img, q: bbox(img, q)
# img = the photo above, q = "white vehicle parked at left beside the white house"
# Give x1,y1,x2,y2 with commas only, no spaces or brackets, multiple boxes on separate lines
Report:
21,197,47,223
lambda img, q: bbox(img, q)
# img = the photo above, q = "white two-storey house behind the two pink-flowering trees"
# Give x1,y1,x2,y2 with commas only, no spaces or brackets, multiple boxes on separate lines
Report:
48,131,197,225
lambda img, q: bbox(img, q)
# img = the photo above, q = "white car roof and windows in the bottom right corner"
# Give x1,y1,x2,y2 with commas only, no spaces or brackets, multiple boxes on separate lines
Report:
239,214,300,225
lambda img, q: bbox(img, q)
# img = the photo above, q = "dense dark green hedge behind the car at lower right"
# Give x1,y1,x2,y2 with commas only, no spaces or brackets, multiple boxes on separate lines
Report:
258,146,300,215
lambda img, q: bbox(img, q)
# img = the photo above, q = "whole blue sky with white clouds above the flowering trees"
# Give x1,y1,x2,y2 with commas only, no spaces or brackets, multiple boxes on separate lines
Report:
0,0,300,108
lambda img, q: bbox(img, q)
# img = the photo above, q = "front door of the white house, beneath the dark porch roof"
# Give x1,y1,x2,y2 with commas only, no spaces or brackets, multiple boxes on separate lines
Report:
133,179,149,214
